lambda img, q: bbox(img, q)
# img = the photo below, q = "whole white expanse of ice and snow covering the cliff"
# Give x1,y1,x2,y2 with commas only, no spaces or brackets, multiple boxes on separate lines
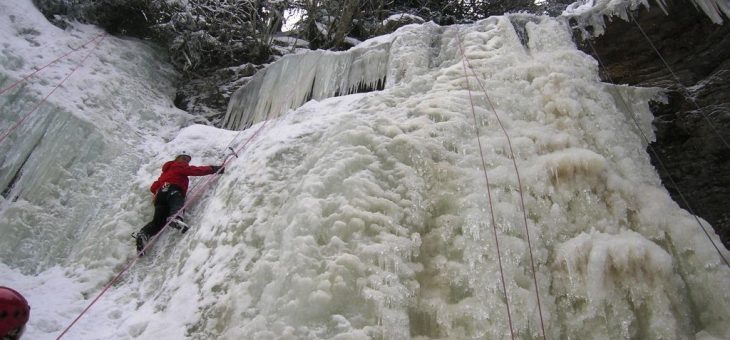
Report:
0,0,730,339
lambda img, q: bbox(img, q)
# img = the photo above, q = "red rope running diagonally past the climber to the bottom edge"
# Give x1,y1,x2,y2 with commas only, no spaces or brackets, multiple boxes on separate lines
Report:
56,117,269,340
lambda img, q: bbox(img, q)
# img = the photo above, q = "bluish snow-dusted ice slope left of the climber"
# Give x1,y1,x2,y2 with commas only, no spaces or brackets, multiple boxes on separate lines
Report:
0,0,186,273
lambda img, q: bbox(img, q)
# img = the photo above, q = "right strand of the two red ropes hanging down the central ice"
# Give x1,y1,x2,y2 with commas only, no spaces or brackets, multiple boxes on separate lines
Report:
456,27,547,339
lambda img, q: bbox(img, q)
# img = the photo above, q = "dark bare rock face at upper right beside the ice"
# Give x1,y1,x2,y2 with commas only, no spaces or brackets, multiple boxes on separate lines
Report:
582,0,730,249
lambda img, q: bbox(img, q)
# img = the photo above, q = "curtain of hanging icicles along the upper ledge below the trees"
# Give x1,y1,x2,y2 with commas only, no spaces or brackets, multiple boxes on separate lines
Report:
223,24,440,129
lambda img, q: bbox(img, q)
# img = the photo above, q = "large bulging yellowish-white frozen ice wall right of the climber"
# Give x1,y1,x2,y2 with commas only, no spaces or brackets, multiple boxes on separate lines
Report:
89,16,730,339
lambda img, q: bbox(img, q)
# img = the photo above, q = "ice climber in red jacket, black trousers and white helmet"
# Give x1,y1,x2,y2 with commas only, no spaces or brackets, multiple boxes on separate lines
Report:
134,151,224,255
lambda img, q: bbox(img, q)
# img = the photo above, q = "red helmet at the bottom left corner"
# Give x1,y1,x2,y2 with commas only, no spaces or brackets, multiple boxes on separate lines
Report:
0,287,30,339
